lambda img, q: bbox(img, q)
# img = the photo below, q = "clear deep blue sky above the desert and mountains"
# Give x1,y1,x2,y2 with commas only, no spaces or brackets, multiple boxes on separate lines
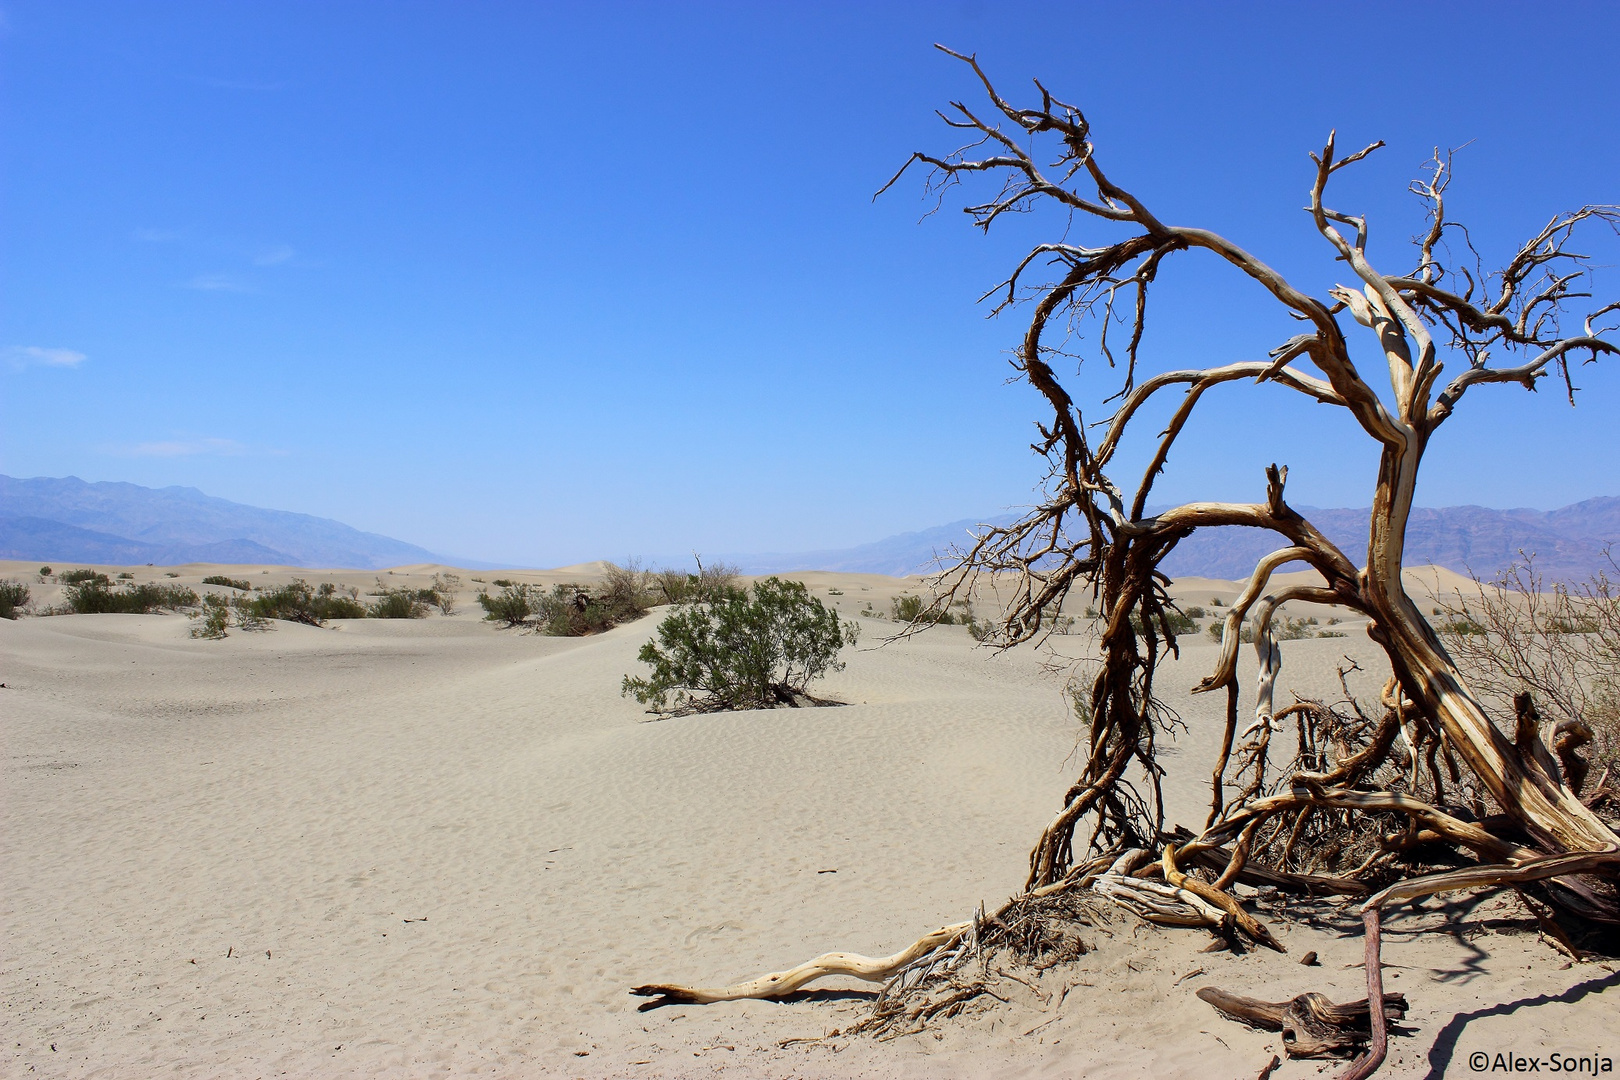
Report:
0,0,1620,565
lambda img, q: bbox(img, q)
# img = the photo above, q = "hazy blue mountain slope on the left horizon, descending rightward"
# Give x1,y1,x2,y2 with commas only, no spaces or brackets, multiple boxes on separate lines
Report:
0,476,456,570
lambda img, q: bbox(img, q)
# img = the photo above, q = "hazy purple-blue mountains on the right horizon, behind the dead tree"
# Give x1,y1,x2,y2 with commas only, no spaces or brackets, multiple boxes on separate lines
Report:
726,497,1620,581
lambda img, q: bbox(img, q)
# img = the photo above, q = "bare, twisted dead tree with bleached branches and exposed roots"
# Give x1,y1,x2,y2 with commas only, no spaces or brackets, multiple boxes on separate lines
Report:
640,50,1620,1075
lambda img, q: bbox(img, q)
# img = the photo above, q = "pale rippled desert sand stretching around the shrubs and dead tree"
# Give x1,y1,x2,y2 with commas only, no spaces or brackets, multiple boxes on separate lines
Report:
0,563,1620,1078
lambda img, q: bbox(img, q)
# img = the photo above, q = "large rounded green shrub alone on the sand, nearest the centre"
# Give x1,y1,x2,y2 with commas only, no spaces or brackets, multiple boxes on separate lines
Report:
620,578,859,712
